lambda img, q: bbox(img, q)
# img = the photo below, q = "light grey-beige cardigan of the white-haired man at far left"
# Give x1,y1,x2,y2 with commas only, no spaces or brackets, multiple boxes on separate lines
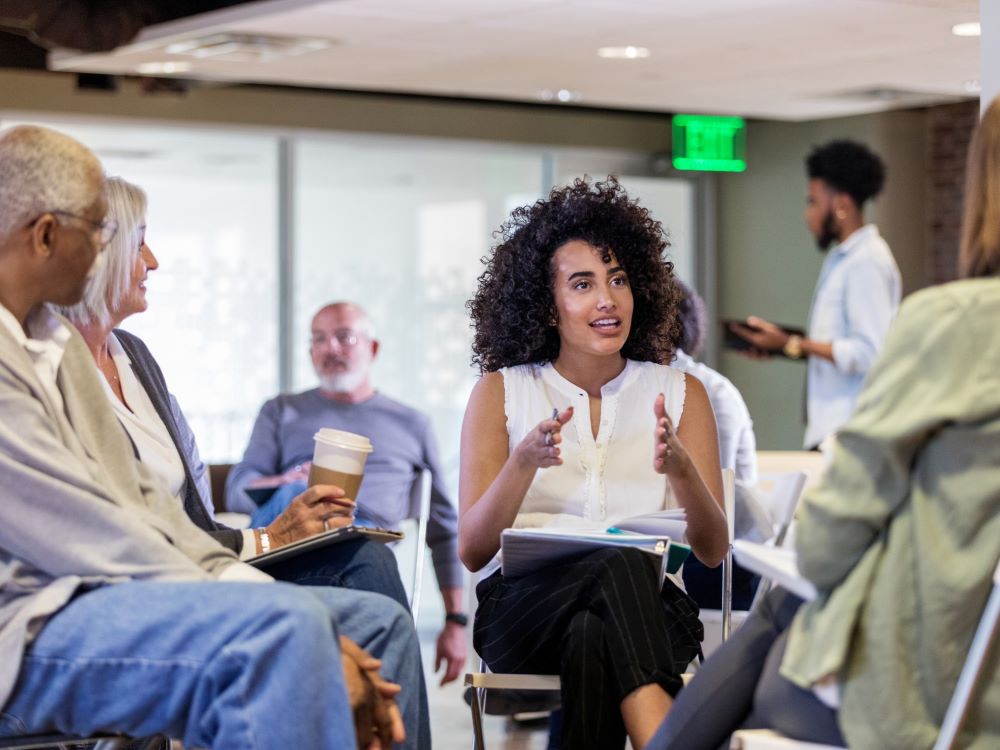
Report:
0,312,236,705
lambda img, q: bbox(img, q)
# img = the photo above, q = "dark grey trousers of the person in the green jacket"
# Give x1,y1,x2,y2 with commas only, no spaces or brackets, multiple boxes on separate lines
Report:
647,588,844,750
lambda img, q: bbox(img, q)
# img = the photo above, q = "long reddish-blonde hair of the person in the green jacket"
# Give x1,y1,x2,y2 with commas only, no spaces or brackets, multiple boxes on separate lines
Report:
958,97,1000,279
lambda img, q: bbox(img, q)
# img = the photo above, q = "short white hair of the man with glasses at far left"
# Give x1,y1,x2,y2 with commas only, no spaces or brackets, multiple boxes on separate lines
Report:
0,125,104,243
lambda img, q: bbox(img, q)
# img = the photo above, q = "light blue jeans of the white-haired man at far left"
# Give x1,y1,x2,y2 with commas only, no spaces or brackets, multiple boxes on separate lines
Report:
0,582,430,750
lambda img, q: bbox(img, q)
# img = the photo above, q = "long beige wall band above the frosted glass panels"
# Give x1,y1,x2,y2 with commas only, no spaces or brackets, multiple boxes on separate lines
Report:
0,70,670,153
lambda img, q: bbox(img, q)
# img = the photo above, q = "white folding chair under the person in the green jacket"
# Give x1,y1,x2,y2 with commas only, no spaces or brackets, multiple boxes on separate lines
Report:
730,563,1000,750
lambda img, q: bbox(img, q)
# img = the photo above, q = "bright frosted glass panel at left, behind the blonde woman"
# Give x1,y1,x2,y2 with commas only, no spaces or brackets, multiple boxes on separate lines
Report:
4,121,278,462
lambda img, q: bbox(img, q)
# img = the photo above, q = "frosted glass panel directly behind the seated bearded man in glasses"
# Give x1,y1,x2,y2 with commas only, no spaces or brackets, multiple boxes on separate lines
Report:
293,138,542,486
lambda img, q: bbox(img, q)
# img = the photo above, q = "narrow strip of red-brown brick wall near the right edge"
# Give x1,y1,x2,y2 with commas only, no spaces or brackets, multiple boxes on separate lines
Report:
927,100,979,284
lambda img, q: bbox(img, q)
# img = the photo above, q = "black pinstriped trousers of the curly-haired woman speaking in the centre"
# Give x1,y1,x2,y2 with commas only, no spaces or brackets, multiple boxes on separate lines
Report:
473,548,701,750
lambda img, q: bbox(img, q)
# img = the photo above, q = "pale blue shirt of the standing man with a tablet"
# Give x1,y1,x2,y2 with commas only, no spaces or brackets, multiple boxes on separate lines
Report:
803,224,902,448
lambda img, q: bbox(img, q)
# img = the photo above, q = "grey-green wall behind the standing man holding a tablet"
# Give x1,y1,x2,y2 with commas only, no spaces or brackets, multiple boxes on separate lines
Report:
717,110,927,449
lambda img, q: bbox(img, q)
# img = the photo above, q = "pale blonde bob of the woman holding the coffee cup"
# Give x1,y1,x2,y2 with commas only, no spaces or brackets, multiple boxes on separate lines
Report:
61,177,146,326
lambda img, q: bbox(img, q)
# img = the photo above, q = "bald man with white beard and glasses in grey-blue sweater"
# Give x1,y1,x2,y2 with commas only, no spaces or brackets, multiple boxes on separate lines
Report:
226,302,467,684
